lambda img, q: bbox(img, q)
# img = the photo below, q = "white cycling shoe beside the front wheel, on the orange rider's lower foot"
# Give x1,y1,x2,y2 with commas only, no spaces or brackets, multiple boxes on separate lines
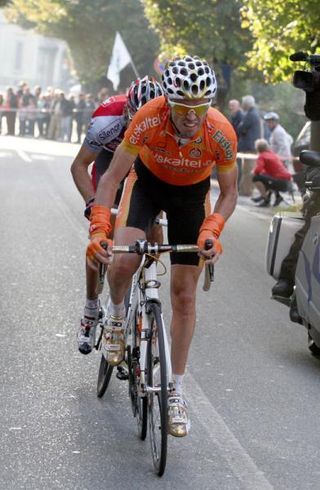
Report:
168,394,191,437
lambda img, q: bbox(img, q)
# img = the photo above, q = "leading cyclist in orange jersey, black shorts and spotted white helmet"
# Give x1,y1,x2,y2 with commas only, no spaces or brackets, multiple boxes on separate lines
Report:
87,56,237,436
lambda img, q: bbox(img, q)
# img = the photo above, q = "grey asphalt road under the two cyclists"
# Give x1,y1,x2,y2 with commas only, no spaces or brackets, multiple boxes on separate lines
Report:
0,137,320,490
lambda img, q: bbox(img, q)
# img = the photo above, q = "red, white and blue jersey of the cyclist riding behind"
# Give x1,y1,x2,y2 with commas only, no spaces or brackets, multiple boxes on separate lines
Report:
83,95,127,153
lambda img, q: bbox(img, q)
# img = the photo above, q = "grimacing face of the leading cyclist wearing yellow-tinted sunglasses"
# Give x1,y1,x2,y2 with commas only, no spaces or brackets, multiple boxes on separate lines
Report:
168,99,210,138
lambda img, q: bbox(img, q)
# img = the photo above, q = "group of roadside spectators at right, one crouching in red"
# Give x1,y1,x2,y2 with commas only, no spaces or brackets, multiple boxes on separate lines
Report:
228,95,293,207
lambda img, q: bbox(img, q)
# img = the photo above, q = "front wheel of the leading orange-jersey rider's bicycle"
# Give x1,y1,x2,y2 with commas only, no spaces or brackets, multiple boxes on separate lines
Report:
147,303,168,476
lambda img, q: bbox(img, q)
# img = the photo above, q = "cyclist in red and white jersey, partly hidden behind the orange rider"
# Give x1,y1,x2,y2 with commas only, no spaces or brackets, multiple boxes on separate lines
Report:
71,76,163,354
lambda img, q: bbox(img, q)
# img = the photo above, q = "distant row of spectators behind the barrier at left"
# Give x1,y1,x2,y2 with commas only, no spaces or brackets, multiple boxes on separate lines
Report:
0,82,108,143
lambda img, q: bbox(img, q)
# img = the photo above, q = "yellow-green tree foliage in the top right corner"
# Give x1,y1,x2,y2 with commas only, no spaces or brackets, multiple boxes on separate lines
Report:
241,0,320,82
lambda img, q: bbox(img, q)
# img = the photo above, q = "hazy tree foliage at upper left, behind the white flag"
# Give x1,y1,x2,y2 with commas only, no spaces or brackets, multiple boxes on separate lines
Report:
5,0,159,88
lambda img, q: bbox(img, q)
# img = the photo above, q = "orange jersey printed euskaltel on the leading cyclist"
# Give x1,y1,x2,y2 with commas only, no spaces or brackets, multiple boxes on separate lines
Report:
121,96,237,185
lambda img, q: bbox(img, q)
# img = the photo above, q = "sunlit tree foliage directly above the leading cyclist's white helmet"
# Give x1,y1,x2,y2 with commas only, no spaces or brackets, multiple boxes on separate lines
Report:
141,0,252,105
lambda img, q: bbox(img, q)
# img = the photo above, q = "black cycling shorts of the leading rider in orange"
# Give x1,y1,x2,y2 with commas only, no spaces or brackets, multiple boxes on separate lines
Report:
116,157,211,265
